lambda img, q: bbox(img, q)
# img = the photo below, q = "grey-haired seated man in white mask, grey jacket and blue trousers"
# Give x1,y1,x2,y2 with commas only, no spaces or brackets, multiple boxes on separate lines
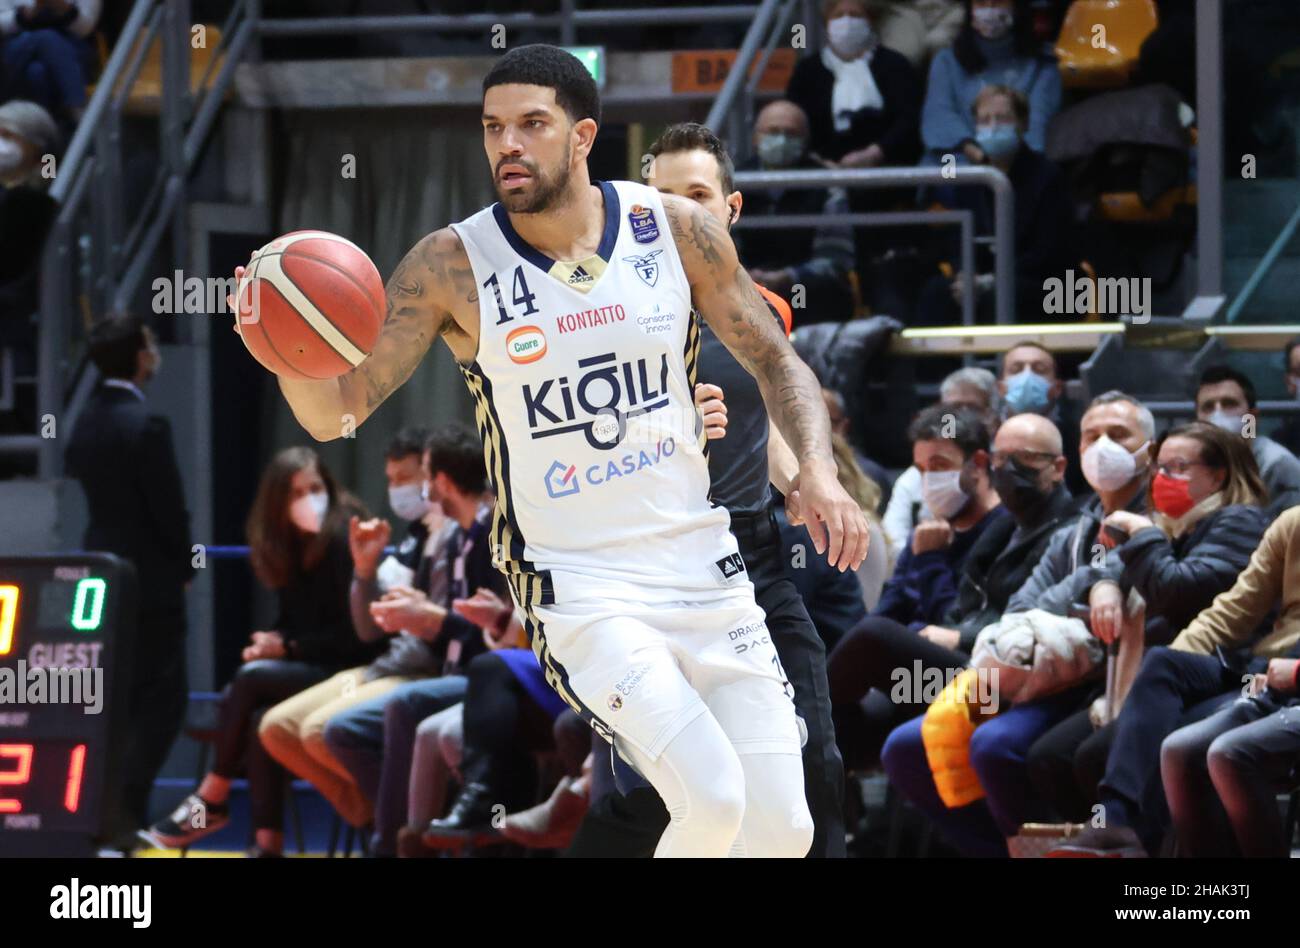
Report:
881,391,1156,857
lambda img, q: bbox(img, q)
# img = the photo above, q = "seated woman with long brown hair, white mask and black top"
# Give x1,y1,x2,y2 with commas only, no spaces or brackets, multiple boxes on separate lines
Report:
148,447,365,856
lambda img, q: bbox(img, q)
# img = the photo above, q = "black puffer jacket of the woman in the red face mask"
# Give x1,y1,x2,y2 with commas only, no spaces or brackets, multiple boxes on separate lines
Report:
1119,503,1269,645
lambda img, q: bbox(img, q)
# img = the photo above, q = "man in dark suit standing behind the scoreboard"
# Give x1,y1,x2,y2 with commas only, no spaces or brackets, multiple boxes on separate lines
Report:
66,316,194,848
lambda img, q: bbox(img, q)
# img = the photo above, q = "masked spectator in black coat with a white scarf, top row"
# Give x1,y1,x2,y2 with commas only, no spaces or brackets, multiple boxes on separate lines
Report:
785,0,922,168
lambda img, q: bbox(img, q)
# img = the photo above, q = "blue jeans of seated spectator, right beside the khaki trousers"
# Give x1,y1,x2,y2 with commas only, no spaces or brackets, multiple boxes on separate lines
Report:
325,675,465,856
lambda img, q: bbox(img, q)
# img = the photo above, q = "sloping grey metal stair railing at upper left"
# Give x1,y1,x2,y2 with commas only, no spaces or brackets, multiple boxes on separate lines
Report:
11,0,260,479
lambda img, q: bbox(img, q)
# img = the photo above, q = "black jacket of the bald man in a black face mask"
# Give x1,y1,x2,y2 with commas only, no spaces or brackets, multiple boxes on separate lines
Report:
945,486,1079,654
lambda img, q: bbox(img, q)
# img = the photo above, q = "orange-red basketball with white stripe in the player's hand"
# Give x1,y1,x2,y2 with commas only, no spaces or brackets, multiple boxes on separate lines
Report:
235,230,386,378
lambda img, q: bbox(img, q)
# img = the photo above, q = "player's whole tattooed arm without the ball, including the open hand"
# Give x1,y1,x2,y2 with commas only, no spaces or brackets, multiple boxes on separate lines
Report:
663,195,868,571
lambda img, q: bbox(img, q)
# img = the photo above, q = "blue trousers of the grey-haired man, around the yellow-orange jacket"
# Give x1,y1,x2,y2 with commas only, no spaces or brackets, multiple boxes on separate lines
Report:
880,688,1083,857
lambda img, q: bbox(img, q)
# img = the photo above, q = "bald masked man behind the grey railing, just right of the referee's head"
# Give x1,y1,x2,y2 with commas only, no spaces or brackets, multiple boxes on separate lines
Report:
731,99,853,323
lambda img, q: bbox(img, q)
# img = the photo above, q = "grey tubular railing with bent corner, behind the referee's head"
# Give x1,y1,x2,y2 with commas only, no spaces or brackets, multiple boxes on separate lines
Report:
736,165,1015,324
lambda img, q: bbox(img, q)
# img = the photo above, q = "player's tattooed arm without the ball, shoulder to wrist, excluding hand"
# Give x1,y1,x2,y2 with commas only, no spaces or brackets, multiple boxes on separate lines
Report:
663,195,835,469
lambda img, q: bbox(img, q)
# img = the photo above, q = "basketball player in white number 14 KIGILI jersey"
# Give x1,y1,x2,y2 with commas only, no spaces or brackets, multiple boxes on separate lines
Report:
237,46,867,857
